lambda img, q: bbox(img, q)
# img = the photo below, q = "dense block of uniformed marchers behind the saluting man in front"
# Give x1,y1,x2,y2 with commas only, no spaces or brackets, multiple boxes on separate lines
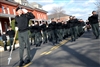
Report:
30,16,85,47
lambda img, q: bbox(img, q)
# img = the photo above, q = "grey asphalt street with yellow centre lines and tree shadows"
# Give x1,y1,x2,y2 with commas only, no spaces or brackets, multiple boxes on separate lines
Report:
0,31,100,67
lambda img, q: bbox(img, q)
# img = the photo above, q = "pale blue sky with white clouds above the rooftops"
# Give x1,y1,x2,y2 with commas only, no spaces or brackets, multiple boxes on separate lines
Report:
28,0,96,20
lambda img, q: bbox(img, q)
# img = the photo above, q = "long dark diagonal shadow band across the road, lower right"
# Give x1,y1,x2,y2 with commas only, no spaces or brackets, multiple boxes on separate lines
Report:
62,45,100,67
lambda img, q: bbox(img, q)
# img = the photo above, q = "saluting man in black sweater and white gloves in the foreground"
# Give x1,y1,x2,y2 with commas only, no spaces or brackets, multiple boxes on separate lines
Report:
15,7,35,66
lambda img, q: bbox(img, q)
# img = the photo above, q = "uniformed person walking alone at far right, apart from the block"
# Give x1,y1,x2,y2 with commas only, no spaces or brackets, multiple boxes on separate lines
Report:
88,11,99,39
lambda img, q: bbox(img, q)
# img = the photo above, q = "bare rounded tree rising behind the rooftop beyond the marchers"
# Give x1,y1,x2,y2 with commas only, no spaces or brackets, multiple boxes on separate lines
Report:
51,6,65,18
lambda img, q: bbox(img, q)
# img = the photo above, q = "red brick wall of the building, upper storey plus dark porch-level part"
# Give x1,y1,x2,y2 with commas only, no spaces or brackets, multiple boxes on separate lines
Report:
0,2,48,31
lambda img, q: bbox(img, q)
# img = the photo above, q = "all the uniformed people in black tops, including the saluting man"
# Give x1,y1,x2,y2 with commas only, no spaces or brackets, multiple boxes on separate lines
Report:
2,7,99,66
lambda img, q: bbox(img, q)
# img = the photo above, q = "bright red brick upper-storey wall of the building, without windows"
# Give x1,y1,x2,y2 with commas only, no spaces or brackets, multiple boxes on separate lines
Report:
0,4,47,19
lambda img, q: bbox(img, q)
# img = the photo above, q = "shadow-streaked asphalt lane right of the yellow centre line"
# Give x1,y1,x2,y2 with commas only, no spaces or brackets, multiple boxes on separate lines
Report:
23,31,100,67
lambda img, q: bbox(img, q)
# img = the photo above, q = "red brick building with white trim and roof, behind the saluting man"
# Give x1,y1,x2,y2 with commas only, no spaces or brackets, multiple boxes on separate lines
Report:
0,0,48,33
